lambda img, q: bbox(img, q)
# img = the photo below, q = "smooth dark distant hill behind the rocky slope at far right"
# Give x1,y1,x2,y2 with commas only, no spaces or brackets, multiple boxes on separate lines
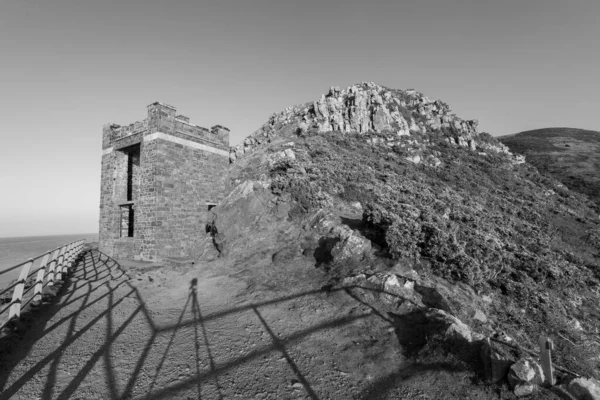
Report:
498,128,600,206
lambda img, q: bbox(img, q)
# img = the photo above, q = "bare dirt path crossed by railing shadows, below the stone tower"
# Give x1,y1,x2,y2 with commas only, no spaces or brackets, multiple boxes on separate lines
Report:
0,251,512,400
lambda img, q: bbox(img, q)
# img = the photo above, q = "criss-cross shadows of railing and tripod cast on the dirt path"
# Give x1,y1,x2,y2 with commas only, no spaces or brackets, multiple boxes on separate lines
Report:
0,250,466,399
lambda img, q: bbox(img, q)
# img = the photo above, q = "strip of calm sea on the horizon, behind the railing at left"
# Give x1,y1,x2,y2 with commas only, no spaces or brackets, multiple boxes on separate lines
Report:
0,233,98,288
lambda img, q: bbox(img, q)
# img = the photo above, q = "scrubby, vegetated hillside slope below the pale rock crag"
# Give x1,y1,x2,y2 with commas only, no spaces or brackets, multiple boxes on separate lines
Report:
223,126,600,382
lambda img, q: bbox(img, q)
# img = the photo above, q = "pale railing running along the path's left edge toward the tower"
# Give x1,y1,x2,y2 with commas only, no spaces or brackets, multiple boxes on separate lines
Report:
0,239,85,330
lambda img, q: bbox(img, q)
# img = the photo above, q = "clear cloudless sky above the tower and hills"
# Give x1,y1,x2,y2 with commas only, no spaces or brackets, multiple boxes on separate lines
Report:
0,0,600,237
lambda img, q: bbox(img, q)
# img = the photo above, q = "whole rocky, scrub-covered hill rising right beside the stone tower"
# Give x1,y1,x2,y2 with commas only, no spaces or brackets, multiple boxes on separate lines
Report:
203,83,600,399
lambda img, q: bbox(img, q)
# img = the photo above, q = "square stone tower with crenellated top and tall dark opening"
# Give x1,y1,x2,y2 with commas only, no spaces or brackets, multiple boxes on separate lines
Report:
100,103,229,261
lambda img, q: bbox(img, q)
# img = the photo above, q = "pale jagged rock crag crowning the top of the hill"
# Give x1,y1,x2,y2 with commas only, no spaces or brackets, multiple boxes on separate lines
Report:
230,82,509,163
